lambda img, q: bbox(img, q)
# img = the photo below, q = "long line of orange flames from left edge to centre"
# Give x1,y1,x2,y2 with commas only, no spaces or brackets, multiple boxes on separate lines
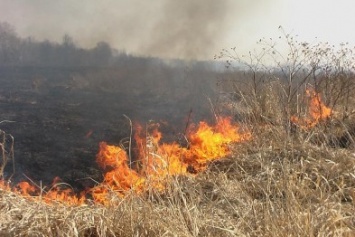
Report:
0,118,251,205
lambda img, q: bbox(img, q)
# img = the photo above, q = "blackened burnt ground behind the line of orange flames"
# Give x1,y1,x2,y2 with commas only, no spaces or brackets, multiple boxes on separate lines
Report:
0,67,216,191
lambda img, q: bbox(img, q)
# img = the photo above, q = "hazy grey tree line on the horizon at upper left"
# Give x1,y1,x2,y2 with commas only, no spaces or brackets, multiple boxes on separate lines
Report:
0,22,133,67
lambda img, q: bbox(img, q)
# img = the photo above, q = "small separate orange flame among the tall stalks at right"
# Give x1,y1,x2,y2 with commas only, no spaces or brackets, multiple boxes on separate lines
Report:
291,89,332,129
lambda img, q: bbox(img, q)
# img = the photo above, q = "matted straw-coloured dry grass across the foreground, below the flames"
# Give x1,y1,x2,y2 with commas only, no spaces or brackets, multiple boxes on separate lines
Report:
0,120,355,236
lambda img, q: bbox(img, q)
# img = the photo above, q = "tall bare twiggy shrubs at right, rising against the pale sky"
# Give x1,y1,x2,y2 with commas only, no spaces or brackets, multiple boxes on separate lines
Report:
216,27,355,137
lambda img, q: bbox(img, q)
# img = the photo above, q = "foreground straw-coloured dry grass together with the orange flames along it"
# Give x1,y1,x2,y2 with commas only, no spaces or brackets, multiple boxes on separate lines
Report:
0,88,355,236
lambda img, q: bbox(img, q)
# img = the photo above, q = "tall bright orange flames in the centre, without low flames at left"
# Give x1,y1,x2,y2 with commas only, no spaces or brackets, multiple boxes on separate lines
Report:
92,118,251,204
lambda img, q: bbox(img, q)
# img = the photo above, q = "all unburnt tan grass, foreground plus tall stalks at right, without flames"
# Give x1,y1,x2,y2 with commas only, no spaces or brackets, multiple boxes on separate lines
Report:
0,32,355,236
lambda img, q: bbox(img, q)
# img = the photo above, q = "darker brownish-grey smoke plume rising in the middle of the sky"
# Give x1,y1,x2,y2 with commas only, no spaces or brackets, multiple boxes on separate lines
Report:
141,0,235,58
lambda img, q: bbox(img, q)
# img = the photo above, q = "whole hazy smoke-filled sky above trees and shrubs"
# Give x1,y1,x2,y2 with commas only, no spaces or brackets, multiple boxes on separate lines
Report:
0,0,355,59
